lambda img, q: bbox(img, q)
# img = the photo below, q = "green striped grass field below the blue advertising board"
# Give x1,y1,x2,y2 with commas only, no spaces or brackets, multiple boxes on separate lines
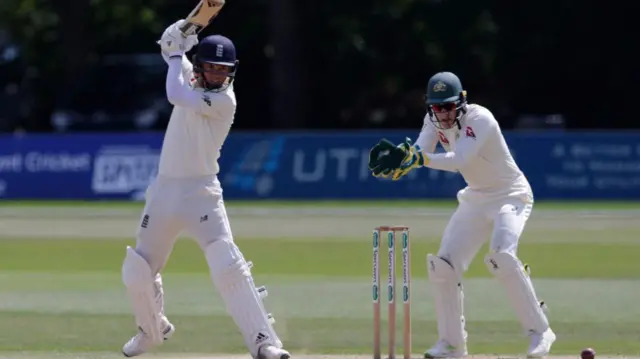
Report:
0,201,640,359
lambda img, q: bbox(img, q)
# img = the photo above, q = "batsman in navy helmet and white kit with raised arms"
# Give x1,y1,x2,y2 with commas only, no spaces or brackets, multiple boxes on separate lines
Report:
122,20,290,359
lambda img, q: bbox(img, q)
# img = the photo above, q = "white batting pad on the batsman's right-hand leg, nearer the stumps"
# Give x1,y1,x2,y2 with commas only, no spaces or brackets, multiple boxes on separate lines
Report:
205,240,282,358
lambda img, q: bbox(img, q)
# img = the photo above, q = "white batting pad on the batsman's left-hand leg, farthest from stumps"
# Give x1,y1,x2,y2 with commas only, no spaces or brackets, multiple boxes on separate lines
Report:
122,246,164,344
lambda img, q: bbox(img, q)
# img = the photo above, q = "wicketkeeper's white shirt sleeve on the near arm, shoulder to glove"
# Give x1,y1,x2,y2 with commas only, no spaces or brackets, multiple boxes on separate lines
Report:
423,111,497,172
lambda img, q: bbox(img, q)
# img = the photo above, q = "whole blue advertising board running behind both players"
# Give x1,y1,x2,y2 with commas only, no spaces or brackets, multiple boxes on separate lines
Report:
0,131,640,200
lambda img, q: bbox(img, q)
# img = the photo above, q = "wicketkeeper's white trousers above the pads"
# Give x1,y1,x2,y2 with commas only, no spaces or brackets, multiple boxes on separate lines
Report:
438,197,533,273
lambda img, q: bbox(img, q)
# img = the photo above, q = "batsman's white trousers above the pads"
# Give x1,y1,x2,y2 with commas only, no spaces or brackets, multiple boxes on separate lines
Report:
136,176,233,273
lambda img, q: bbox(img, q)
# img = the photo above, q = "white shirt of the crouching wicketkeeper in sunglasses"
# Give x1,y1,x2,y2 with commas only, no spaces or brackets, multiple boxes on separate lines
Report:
416,104,533,202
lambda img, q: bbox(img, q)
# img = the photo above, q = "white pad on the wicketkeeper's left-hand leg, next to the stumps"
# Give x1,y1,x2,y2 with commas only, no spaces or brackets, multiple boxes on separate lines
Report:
427,254,467,347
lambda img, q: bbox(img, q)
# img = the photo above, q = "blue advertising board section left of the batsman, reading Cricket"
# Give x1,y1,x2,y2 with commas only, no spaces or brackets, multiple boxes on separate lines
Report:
0,133,163,199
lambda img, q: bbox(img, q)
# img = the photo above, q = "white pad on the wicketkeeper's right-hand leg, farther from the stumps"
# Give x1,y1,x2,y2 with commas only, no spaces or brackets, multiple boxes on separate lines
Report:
484,253,549,334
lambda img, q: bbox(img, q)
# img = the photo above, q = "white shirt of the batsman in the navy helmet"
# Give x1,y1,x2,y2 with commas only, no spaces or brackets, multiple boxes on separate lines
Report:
158,56,236,178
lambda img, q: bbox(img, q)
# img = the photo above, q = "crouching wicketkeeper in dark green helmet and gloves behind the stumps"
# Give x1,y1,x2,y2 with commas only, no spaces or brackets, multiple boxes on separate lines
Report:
369,72,556,358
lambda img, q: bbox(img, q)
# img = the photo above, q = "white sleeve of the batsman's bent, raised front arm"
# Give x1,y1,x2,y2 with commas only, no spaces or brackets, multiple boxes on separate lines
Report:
165,56,234,117
